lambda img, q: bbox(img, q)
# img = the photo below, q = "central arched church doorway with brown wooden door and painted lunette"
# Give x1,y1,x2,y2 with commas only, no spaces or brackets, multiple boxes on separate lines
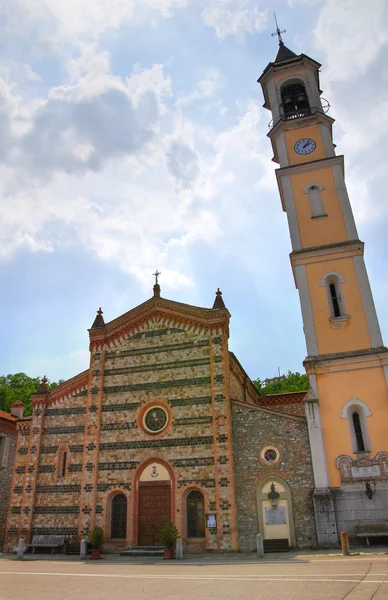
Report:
137,461,173,546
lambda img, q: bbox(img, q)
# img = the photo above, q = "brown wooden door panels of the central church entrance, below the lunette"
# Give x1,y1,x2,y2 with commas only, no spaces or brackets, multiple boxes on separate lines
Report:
138,482,171,546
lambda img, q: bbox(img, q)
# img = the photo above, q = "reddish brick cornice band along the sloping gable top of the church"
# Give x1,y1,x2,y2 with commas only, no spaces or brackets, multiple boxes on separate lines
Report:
89,297,230,352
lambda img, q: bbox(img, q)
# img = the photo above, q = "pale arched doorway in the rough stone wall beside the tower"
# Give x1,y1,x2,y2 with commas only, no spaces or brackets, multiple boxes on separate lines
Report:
257,477,296,547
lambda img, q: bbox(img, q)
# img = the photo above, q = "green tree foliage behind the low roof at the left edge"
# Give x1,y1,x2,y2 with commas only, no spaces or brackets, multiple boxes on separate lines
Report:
0,373,63,417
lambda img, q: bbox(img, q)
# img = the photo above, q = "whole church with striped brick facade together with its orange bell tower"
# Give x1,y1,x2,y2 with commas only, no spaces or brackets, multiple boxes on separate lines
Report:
5,39,388,551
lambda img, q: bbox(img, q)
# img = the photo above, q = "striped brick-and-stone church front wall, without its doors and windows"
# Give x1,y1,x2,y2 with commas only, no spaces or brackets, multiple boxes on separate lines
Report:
6,286,313,551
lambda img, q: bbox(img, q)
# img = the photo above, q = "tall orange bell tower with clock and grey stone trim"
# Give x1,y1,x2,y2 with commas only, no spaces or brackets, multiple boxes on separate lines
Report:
258,34,388,545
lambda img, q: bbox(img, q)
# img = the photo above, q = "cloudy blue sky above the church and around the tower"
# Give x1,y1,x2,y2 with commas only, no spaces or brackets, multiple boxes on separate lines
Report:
0,0,388,381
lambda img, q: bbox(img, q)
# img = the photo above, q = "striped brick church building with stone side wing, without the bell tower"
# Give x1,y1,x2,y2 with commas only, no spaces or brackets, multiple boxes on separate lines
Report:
7,284,315,551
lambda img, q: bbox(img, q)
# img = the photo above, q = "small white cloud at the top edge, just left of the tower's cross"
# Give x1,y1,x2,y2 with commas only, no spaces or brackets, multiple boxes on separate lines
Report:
202,0,267,42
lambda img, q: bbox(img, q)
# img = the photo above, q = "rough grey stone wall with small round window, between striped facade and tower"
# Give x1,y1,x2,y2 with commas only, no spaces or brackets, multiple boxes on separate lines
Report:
232,402,316,551
